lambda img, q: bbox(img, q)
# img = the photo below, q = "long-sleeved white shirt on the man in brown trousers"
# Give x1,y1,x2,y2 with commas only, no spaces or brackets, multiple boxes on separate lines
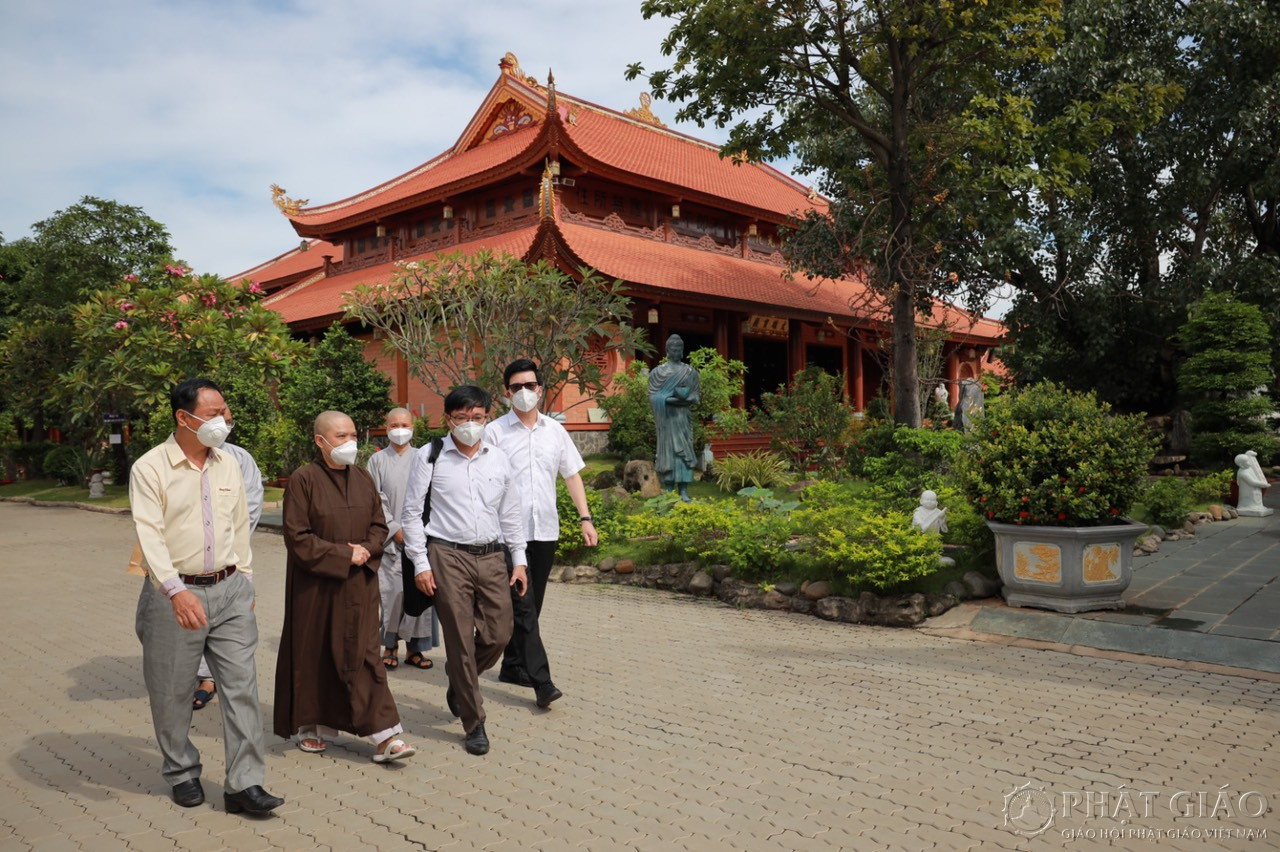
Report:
401,435,526,573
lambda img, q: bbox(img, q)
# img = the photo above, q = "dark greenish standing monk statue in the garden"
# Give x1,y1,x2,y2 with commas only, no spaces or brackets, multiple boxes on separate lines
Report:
649,334,701,503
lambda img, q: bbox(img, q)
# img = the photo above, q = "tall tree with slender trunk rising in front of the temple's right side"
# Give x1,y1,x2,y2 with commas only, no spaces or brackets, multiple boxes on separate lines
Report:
627,0,1073,426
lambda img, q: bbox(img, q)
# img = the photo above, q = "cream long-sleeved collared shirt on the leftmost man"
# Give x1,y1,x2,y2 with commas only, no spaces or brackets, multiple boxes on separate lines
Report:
129,435,252,597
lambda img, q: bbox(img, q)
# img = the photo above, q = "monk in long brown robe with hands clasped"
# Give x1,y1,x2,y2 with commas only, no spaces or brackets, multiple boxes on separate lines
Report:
275,411,415,764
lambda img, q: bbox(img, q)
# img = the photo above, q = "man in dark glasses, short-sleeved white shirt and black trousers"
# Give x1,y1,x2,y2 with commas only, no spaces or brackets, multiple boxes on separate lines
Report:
485,358,598,709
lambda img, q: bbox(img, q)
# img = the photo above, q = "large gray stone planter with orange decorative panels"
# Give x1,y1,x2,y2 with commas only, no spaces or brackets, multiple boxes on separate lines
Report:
987,521,1147,613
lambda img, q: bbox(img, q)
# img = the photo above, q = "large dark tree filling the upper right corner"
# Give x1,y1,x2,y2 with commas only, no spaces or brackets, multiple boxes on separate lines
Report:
1005,0,1280,411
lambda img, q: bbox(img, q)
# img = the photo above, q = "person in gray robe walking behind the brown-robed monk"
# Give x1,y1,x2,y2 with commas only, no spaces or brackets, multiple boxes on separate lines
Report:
365,408,440,669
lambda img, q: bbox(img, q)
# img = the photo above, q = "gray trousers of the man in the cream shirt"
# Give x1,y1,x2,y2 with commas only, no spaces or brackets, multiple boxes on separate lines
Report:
136,573,266,792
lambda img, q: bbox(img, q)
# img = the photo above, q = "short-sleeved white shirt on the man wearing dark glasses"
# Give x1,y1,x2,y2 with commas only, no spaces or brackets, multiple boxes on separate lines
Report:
484,411,586,541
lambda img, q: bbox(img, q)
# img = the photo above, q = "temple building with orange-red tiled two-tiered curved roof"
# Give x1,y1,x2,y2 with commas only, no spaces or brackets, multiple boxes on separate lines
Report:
236,54,1004,438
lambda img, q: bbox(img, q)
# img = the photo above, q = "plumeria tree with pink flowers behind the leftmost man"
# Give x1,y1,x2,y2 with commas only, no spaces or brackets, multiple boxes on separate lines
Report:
56,261,302,457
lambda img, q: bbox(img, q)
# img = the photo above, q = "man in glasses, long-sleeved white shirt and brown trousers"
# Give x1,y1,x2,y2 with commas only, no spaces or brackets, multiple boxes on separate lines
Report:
401,385,529,755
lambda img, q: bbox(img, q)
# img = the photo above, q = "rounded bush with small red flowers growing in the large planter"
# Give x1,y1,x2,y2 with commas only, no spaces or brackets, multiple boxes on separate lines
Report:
955,383,1160,527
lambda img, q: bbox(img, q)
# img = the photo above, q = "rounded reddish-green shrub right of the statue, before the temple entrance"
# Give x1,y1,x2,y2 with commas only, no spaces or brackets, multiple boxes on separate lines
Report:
755,366,852,476
